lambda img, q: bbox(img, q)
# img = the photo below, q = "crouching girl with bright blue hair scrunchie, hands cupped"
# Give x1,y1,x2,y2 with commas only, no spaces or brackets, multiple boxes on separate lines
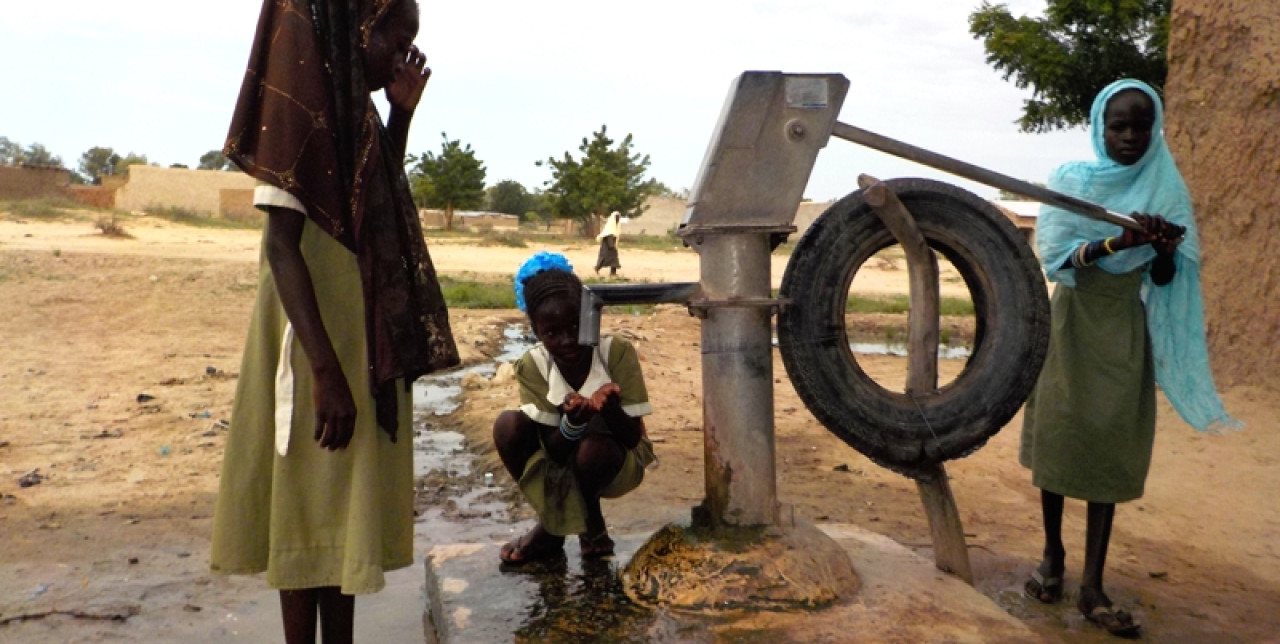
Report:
493,252,654,566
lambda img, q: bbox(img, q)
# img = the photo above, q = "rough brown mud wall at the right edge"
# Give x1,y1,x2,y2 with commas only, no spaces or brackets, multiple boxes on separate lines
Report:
1165,0,1280,390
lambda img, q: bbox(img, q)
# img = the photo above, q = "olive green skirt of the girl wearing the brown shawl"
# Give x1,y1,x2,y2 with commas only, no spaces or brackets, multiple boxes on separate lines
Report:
210,220,413,594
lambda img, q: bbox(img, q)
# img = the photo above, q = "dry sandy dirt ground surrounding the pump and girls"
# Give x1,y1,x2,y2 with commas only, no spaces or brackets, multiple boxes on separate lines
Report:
0,214,1280,641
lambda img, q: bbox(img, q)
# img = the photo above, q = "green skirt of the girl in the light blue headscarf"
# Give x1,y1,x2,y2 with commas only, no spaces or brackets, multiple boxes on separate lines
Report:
1019,268,1156,503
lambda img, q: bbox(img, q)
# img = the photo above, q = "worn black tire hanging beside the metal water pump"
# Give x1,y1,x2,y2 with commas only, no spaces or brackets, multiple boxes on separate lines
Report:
778,179,1050,479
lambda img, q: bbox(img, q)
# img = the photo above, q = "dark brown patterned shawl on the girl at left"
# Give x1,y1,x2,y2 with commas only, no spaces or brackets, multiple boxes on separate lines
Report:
224,0,458,437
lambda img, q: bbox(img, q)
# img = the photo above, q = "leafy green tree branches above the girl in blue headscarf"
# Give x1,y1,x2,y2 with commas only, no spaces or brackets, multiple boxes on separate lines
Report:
969,0,1172,132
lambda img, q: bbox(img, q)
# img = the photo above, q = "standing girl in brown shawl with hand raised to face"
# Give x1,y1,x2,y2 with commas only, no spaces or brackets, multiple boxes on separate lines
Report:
211,0,458,644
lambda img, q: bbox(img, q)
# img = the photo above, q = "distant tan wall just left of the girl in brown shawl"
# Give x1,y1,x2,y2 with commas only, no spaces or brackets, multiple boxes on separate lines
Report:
115,165,253,216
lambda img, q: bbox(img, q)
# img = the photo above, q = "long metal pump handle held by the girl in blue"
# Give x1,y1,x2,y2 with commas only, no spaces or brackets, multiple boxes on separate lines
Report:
831,120,1143,232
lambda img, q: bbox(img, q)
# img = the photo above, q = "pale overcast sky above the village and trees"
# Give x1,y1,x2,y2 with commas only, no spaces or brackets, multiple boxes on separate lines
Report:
0,0,1092,201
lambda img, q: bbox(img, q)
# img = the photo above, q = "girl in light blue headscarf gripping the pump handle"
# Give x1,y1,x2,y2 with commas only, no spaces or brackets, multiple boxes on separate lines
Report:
1019,79,1238,635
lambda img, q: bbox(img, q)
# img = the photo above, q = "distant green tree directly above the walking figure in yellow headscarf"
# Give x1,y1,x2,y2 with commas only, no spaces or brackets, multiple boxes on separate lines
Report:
538,125,659,234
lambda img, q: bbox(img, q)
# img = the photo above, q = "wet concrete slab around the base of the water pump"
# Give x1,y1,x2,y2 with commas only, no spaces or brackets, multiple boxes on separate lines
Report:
425,525,1041,644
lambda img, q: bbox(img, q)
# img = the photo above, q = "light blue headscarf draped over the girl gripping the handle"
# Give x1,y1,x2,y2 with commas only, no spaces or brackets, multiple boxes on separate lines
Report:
1036,79,1240,431
